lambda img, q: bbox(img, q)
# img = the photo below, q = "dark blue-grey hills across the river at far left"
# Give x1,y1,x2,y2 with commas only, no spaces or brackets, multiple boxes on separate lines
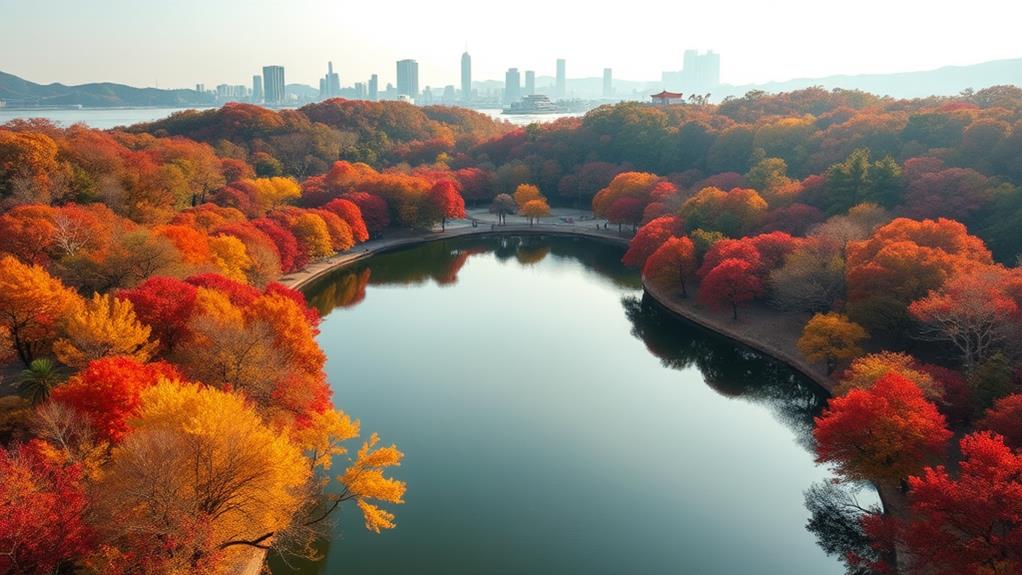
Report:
0,71,213,108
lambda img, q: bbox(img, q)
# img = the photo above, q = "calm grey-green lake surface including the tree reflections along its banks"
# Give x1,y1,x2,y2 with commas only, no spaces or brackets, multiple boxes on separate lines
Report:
286,238,854,575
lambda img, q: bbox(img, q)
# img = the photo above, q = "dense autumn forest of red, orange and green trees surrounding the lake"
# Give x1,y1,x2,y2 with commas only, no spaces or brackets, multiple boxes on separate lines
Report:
0,87,1022,575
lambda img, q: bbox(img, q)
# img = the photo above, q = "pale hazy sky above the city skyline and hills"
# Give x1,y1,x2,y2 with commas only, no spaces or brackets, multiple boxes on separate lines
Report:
0,0,1022,88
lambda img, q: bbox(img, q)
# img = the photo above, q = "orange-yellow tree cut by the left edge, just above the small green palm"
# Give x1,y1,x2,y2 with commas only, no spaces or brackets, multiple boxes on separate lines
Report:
0,255,81,367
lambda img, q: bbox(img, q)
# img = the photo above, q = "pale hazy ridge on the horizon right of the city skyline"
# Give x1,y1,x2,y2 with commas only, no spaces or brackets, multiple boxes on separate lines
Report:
713,58,1022,100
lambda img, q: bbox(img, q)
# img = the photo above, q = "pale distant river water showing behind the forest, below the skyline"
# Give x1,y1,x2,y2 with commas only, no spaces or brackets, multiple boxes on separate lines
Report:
0,108,582,130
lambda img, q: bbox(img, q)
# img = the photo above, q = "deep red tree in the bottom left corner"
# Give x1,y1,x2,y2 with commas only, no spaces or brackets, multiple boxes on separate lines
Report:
0,443,94,573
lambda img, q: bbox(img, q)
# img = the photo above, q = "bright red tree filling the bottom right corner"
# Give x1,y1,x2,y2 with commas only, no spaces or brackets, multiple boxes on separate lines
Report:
903,432,1022,575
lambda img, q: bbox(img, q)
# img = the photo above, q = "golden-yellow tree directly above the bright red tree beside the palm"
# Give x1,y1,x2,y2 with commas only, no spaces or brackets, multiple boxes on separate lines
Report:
53,293,159,368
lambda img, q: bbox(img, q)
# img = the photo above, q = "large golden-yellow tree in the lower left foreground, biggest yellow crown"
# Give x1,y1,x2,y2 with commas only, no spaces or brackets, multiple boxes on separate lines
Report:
96,380,310,573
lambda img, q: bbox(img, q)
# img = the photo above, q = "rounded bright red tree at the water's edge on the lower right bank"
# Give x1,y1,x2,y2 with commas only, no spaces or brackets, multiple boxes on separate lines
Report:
812,374,950,484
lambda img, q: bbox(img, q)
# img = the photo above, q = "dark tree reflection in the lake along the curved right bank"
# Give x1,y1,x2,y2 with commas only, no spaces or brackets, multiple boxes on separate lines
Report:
621,296,827,450
